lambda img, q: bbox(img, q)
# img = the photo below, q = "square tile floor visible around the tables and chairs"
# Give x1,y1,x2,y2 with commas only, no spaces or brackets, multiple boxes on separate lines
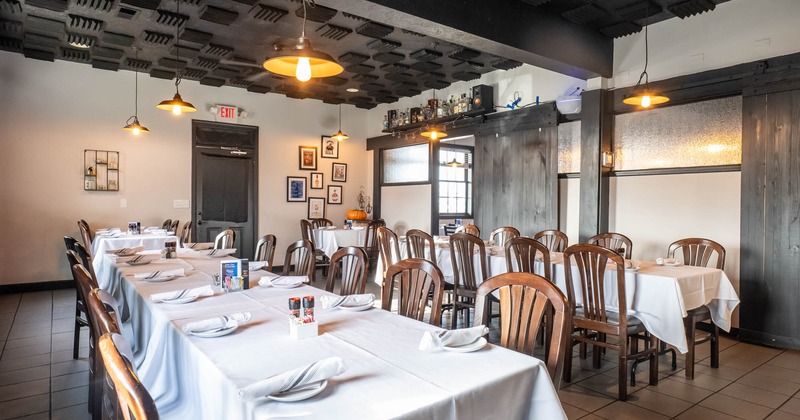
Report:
0,290,800,420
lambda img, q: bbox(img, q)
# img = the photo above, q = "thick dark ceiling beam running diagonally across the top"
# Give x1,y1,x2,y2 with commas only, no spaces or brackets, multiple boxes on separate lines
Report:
325,0,614,80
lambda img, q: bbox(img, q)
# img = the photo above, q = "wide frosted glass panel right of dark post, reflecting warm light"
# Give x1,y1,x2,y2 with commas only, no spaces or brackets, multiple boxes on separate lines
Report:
612,96,742,172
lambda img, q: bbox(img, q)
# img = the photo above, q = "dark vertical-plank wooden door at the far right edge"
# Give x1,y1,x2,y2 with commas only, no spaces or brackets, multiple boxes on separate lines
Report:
739,70,800,349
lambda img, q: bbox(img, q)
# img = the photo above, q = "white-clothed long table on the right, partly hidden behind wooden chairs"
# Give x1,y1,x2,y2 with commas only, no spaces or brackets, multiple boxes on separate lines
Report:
376,238,739,353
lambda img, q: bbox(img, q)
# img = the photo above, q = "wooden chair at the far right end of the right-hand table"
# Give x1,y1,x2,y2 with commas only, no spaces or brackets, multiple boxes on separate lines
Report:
667,238,725,379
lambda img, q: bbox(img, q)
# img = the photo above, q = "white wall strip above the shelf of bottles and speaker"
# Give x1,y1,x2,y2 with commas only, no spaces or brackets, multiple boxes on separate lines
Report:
367,64,586,137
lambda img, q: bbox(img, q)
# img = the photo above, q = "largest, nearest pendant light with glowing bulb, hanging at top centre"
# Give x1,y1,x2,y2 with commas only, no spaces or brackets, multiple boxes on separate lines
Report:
264,0,344,82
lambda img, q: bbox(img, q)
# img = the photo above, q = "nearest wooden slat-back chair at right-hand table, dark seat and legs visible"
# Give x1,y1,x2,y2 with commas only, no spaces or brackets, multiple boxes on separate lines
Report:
564,244,658,401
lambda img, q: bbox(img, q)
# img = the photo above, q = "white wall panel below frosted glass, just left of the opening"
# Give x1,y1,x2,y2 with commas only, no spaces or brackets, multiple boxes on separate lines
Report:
381,184,436,234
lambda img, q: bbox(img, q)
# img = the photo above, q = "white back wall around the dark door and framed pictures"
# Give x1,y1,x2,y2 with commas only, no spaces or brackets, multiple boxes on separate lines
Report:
0,52,372,284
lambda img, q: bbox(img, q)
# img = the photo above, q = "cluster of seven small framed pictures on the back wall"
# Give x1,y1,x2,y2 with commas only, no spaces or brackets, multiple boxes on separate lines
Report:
286,136,347,219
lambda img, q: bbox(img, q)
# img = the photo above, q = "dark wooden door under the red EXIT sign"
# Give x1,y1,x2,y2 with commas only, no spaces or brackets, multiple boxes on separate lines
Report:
192,120,258,258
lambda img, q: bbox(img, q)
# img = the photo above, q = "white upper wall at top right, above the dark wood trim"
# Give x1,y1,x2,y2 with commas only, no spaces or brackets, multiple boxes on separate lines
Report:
609,0,800,88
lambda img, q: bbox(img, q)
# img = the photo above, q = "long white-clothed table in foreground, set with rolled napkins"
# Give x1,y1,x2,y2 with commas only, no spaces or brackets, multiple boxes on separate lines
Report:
98,250,566,419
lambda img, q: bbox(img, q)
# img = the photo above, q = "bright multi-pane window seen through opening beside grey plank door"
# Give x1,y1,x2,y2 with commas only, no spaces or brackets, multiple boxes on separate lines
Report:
439,146,472,217
